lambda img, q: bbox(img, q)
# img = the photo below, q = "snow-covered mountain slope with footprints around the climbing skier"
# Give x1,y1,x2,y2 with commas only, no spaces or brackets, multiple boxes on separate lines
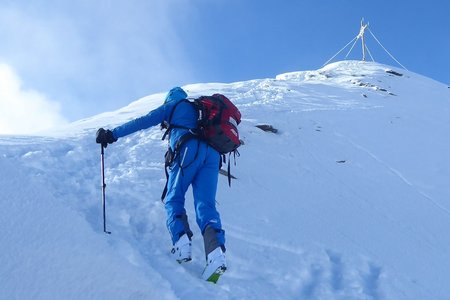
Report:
0,61,450,299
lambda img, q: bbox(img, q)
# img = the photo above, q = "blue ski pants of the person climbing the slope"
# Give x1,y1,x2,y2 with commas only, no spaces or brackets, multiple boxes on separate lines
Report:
165,138,225,245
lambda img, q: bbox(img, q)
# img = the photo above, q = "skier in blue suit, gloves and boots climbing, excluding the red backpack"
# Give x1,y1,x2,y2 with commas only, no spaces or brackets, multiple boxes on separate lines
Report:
96,87,227,282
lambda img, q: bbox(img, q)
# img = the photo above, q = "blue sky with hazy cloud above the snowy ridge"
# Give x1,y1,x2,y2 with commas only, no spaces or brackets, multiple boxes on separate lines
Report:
0,0,450,133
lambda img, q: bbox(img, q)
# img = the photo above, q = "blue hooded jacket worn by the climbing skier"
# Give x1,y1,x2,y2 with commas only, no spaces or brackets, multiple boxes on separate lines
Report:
112,87,198,150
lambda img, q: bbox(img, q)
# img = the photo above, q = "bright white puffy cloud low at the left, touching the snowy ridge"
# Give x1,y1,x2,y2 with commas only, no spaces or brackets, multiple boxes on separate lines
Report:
0,63,67,134
